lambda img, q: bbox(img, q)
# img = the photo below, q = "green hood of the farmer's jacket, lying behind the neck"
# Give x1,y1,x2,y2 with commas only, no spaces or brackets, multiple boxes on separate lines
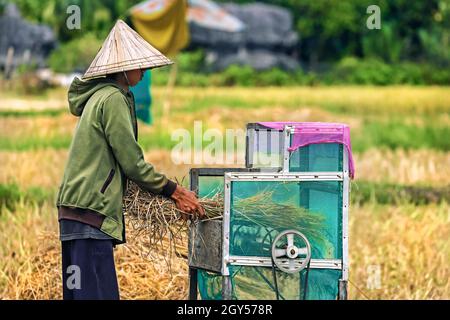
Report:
68,78,124,117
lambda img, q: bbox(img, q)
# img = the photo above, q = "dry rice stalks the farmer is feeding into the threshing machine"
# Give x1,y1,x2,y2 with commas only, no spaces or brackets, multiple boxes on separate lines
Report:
124,181,326,271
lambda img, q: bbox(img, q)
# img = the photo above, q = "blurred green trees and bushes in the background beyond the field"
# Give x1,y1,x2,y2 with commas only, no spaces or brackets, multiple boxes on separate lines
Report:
9,0,450,87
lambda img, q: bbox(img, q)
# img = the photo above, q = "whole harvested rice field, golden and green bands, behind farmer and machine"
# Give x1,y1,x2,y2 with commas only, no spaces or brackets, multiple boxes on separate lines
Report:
0,86,450,299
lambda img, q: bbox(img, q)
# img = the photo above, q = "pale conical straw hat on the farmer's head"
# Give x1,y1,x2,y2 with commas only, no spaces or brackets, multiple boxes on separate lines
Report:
83,20,173,80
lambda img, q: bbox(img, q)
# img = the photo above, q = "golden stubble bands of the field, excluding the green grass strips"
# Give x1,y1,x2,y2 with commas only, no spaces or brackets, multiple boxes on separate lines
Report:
0,87,450,299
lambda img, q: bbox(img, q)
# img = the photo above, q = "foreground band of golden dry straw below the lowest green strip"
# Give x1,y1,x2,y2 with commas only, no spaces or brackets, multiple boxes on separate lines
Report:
0,203,450,299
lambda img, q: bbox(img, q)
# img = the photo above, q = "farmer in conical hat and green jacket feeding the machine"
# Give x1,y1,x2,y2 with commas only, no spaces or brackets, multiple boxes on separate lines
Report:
56,20,204,299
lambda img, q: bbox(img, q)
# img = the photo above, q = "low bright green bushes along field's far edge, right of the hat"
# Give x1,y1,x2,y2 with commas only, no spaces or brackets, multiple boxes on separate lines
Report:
152,53,450,87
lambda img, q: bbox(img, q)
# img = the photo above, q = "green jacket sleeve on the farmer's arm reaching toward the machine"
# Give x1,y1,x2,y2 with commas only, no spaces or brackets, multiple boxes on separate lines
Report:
102,92,176,197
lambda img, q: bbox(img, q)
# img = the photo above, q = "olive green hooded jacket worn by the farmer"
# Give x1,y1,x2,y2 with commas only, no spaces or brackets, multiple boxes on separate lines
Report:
56,78,176,243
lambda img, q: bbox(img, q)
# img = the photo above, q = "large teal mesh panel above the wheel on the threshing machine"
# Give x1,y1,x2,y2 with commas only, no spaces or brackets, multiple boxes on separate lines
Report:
230,181,342,259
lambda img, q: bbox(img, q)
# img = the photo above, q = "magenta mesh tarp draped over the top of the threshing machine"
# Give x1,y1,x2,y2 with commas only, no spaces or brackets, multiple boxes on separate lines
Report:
258,122,355,179
